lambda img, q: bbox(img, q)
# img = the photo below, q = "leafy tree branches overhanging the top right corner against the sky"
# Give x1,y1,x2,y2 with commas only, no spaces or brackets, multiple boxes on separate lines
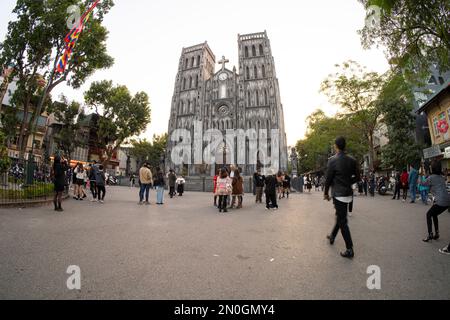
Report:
359,0,450,80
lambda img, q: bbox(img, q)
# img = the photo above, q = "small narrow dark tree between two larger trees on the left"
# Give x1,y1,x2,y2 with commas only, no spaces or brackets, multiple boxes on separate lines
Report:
49,96,86,160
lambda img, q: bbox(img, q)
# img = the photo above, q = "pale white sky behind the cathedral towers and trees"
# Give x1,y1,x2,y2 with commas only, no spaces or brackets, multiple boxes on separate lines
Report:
0,0,389,145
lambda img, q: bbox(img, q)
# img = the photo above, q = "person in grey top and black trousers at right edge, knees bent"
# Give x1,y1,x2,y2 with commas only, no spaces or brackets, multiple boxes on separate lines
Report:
421,161,450,242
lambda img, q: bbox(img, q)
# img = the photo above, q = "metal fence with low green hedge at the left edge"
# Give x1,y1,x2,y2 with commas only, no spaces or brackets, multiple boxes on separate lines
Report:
0,161,61,205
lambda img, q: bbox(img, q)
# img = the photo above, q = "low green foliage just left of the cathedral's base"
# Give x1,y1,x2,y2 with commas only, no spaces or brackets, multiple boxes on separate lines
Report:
130,133,168,169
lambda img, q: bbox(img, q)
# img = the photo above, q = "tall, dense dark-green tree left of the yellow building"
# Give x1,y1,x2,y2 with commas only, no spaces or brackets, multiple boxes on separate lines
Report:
377,73,421,170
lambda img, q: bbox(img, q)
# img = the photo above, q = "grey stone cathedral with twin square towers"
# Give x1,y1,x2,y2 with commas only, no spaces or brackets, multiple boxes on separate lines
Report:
166,32,287,176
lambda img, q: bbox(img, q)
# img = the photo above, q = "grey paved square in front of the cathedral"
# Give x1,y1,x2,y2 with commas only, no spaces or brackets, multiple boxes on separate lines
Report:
0,187,450,299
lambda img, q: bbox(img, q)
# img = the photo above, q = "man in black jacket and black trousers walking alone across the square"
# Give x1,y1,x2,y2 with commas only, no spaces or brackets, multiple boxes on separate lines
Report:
324,137,360,258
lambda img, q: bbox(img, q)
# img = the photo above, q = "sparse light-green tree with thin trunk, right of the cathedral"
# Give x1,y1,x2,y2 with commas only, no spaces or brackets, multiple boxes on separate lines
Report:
321,61,384,170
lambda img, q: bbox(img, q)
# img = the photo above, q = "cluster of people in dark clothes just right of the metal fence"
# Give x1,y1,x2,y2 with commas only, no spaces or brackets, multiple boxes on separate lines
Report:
51,155,107,212
